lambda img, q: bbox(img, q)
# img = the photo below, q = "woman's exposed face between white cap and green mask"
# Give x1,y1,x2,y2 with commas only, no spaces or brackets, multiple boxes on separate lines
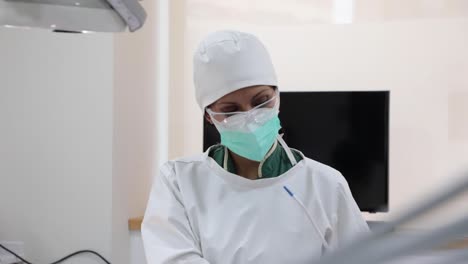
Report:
206,85,277,123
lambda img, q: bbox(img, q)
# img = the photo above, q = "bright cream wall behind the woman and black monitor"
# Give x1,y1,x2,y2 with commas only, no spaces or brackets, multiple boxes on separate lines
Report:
171,0,468,228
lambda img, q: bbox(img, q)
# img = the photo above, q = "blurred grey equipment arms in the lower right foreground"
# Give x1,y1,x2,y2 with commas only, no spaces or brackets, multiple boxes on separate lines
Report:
314,173,468,264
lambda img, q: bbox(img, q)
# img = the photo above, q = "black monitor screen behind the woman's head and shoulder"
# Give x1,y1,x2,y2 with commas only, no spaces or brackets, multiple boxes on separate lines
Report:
203,91,389,212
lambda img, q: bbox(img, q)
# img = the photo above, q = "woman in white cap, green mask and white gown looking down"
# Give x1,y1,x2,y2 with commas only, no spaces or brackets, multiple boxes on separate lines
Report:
142,31,368,264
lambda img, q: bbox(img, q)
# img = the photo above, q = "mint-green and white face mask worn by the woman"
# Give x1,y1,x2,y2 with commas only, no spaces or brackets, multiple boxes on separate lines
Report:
212,100,281,161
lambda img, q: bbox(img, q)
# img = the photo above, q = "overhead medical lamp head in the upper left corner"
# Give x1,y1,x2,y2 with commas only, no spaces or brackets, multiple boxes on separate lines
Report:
0,0,146,33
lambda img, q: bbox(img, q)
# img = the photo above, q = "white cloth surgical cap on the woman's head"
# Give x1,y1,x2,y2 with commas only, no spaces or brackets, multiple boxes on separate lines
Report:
193,31,278,111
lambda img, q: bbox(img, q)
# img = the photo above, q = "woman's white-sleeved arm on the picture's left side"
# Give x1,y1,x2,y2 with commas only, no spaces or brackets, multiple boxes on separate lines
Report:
141,164,209,264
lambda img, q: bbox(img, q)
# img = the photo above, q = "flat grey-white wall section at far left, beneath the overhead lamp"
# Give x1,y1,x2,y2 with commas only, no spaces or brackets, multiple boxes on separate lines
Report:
0,28,113,263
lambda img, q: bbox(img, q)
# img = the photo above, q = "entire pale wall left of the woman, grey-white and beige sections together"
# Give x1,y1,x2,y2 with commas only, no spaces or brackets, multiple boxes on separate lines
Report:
0,1,172,264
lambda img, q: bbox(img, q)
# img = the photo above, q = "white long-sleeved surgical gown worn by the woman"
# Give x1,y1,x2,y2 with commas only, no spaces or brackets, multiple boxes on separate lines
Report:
142,151,368,264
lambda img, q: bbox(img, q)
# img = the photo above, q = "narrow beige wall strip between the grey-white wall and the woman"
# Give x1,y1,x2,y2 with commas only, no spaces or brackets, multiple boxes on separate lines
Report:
112,1,158,264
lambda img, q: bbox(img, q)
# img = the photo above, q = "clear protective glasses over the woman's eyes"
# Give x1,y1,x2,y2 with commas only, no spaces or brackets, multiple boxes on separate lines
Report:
206,93,279,124
